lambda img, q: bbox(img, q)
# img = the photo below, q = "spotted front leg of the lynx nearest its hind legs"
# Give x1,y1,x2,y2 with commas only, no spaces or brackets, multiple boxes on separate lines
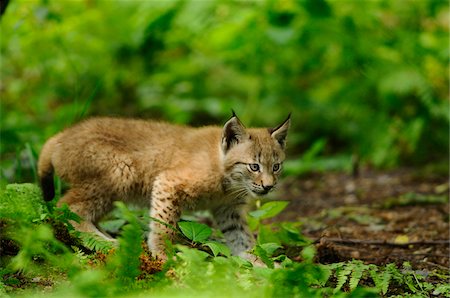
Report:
148,178,181,261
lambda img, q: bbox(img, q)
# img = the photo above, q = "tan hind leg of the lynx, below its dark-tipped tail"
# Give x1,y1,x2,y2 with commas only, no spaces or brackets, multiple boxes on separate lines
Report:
58,185,115,241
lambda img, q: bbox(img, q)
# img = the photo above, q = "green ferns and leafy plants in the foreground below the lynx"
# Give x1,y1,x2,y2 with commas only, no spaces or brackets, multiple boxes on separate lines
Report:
0,184,450,297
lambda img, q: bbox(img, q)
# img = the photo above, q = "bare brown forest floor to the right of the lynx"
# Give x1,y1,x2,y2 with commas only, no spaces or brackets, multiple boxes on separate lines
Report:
272,170,450,270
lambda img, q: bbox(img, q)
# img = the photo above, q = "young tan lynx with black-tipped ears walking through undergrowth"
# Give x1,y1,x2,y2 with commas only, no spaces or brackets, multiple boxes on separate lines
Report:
38,113,290,259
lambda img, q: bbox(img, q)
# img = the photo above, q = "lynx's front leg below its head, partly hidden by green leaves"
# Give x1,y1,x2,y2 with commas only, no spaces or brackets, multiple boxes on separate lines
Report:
213,202,255,261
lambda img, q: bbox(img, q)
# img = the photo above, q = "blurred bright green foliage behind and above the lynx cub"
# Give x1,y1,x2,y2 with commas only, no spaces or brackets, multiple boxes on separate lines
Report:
0,0,450,184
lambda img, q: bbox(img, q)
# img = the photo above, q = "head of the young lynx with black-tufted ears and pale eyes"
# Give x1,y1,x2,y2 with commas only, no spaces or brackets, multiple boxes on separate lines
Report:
221,112,290,196
